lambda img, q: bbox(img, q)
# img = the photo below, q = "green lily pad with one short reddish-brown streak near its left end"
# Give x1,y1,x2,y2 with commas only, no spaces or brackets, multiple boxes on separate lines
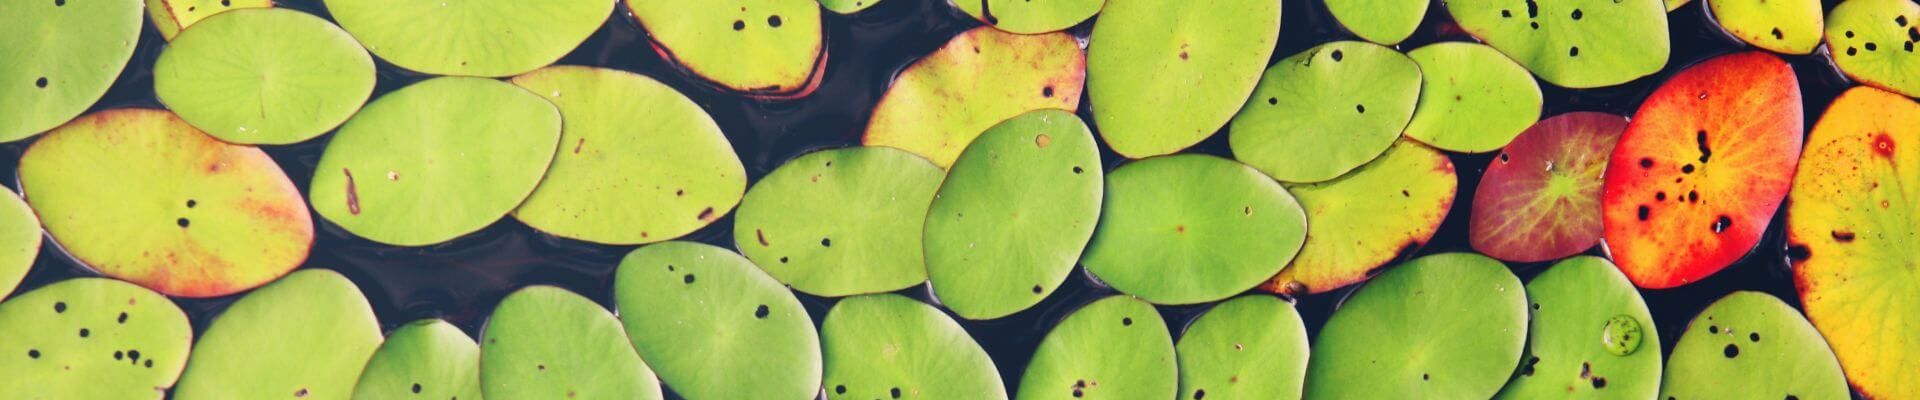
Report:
309,77,561,246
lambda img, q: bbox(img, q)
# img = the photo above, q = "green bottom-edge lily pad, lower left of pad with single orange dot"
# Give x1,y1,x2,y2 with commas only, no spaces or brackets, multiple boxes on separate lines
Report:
820,294,1006,400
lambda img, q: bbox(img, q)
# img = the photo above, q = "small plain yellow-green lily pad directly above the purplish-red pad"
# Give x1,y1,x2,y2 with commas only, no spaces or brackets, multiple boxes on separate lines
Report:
1407,42,1542,152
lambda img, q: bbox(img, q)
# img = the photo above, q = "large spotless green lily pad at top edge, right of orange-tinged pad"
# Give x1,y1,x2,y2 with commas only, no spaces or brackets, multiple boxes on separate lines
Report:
1087,0,1281,158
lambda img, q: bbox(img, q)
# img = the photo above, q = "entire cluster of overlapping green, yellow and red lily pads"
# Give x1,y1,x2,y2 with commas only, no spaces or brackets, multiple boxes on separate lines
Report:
0,0,1920,400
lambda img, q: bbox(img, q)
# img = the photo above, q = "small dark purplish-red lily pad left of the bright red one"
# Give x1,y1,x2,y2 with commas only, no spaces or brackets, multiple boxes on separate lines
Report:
1469,112,1626,262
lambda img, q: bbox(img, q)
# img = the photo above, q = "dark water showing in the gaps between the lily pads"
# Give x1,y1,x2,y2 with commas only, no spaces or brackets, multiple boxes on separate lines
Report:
0,0,1849,396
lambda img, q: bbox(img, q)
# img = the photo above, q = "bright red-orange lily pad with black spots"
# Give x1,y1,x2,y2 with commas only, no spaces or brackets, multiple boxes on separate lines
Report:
1601,52,1803,288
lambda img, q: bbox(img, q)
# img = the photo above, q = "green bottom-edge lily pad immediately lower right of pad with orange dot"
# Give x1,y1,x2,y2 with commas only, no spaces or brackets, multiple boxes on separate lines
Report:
1016,296,1179,400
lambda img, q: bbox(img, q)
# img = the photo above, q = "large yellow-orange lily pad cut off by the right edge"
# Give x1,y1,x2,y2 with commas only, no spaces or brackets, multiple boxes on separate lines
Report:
1786,87,1920,398
